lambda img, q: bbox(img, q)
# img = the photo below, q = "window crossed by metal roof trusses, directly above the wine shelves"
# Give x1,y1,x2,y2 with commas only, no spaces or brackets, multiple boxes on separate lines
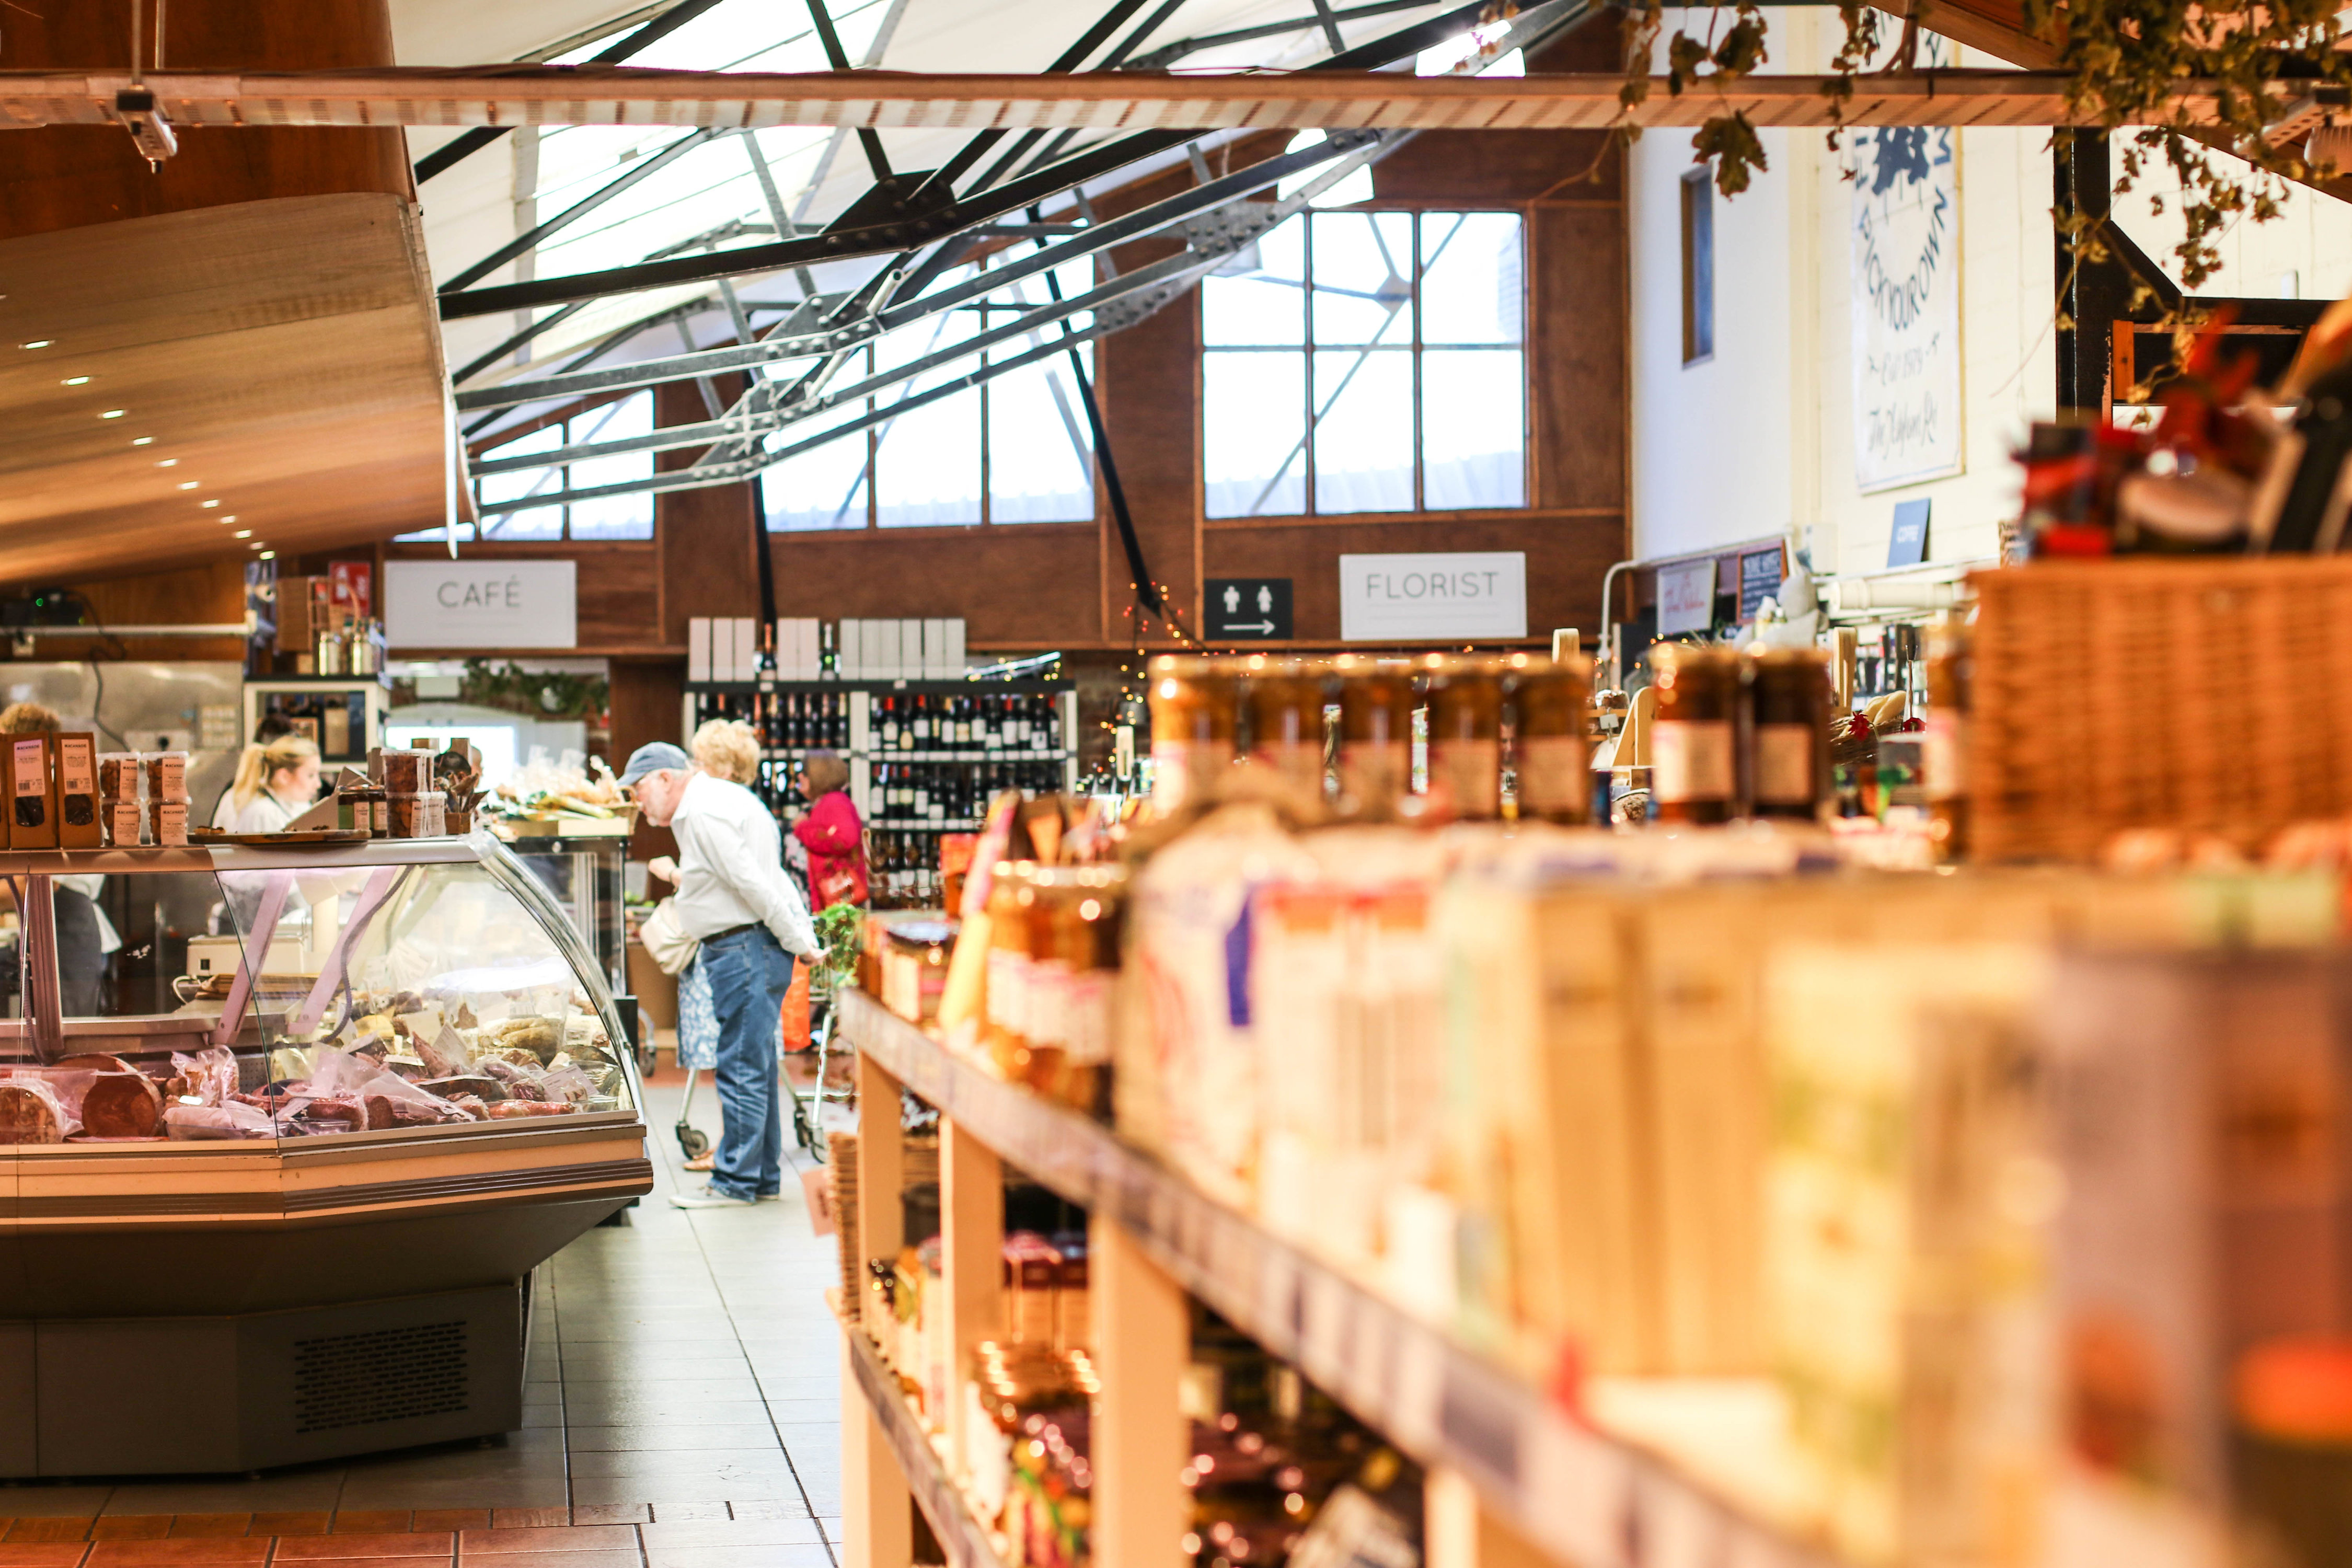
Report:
762,254,1094,531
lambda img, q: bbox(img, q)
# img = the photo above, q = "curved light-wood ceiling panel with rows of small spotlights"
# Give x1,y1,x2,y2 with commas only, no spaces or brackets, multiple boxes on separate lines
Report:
0,195,445,583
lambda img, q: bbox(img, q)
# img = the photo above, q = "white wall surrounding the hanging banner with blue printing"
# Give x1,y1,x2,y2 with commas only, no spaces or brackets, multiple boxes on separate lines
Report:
1628,7,2056,573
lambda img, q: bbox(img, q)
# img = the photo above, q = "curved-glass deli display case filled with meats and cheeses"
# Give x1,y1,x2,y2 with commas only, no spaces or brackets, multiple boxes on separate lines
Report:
0,835,652,1479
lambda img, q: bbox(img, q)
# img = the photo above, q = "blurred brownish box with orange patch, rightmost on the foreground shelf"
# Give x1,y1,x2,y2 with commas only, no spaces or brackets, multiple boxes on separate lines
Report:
2046,952,2352,1568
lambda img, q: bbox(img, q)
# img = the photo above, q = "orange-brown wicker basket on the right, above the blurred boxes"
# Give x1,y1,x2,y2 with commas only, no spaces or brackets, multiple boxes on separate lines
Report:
1969,557,2352,860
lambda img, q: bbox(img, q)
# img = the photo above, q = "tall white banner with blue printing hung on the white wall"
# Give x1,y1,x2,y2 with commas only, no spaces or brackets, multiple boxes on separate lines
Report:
1849,124,1962,491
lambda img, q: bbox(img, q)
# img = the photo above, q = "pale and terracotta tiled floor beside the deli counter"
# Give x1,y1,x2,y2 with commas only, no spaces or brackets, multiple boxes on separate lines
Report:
0,1069,842,1568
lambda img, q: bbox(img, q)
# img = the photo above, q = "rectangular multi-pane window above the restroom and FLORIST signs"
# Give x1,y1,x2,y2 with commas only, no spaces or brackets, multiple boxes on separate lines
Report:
1200,212,1527,517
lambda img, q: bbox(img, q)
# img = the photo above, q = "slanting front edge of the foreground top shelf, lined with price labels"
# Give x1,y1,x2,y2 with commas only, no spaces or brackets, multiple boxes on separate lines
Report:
842,992,1832,1568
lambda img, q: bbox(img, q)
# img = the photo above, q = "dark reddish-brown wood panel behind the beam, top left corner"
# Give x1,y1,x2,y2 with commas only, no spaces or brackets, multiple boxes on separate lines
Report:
0,0,414,237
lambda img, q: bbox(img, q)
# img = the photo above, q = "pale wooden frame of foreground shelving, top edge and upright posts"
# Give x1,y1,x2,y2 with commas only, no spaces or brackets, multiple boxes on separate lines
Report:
842,992,1832,1568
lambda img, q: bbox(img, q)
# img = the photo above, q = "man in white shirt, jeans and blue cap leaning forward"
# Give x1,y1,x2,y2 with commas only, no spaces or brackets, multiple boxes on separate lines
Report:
621,741,816,1208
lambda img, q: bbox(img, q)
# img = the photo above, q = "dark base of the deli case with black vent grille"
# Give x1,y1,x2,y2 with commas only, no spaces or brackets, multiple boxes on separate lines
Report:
0,1284,525,1479
